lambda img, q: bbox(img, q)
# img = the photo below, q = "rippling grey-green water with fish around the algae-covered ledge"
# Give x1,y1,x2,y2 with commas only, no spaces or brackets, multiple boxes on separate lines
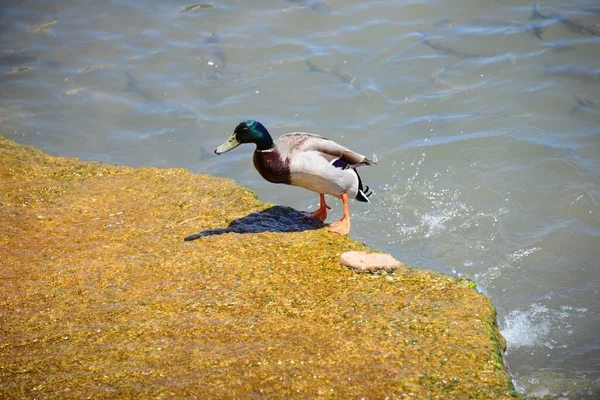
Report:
0,0,600,399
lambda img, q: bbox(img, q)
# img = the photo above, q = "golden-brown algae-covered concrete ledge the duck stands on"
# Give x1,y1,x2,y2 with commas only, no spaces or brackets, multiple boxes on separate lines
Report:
0,138,518,399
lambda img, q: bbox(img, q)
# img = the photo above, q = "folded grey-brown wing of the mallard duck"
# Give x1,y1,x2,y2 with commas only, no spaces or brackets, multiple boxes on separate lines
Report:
276,132,377,168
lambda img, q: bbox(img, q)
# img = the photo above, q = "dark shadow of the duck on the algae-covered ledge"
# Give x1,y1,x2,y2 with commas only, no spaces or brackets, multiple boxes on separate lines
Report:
184,206,325,242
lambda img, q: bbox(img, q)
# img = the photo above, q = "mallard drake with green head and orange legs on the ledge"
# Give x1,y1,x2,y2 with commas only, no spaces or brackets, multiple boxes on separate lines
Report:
215,120,377,235
